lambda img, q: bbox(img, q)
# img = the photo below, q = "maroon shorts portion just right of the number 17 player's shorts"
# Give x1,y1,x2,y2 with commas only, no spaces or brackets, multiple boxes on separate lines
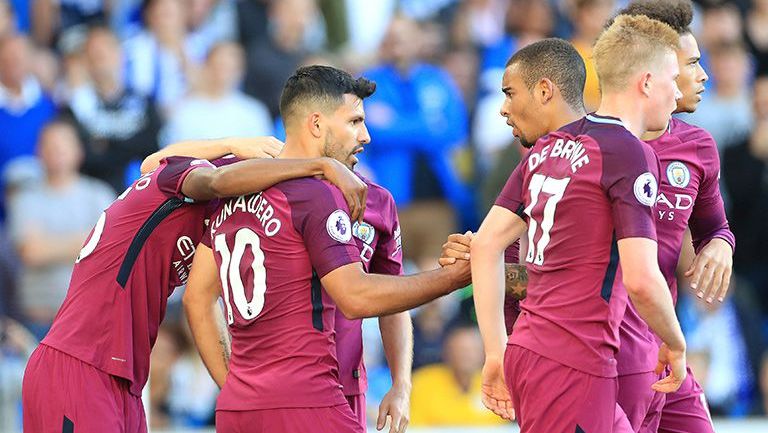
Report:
618,371,666,433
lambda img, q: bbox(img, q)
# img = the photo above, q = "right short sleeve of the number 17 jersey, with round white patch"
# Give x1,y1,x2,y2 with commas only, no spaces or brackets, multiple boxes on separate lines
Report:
601,136,659,240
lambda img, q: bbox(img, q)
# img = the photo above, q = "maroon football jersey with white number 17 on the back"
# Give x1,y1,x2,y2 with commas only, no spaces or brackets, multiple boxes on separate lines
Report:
496,115,659,377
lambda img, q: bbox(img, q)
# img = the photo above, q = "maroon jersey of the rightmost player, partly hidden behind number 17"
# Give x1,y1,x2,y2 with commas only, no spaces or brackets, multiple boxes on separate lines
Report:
617,118,735,374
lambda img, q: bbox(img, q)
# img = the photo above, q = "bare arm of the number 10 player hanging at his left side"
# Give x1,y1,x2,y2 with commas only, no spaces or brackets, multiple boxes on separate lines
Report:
183,244,231,388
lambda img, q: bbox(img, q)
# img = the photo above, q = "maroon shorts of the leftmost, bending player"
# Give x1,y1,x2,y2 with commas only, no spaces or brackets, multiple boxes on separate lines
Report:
21,344,147,433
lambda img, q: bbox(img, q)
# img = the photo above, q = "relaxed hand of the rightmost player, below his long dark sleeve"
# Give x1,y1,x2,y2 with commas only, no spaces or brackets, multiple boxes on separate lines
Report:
685,238,733,303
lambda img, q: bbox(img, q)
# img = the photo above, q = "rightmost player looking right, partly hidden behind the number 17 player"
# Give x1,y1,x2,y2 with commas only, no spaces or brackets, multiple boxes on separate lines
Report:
617,0,735,433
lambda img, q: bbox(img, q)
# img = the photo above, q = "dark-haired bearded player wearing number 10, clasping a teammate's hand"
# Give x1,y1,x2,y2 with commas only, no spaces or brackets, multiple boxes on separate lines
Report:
185,66,469,433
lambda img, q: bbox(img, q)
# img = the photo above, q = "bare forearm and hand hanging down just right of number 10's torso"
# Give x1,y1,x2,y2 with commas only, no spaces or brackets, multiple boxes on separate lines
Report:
376,312,413,433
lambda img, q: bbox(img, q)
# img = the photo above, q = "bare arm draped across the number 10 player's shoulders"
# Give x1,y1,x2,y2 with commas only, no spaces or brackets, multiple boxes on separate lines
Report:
182,157,368,220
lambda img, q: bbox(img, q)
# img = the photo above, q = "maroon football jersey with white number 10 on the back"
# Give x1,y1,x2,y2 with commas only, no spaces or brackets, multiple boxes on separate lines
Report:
206,178,360,410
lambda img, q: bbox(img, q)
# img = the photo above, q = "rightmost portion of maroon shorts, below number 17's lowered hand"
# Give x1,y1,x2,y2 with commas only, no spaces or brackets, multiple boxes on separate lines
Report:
654,368,715,433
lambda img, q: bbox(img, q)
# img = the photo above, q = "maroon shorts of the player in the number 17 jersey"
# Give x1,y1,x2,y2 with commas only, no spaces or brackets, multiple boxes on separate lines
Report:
504,345,618,433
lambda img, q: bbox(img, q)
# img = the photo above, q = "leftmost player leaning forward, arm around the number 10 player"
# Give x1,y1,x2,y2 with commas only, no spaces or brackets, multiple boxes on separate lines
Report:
22,138,372,433
